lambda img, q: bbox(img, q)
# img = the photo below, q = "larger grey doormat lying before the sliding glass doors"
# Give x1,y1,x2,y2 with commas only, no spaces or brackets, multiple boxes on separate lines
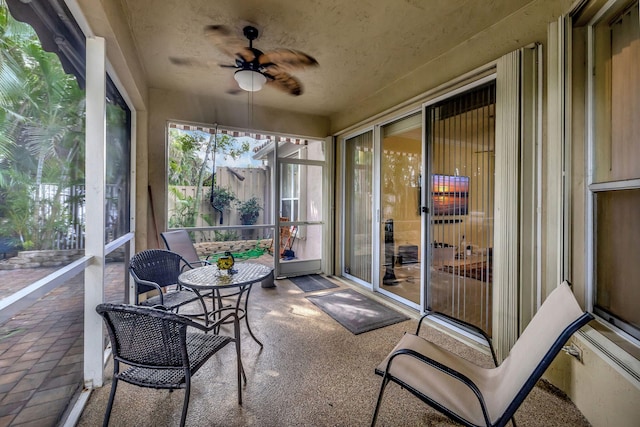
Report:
307,289,409,335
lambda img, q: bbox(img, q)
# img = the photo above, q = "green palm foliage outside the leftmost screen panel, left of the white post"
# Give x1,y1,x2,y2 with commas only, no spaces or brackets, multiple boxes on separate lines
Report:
0,0,85,249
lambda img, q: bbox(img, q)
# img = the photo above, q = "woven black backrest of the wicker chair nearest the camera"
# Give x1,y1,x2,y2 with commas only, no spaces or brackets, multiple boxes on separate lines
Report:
96,303,189,368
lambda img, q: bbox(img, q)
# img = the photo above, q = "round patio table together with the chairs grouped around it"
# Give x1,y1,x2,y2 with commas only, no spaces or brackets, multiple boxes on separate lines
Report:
96,232,273,426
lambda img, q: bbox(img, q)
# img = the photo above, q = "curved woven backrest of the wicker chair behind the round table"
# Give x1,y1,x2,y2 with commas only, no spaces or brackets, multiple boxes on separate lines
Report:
129,249,186,293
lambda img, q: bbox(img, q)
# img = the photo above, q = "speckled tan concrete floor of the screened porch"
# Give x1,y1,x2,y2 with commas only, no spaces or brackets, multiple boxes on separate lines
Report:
78,280,589,427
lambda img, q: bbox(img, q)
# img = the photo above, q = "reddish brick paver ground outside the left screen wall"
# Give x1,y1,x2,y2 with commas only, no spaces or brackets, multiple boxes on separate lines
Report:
0,263,125,427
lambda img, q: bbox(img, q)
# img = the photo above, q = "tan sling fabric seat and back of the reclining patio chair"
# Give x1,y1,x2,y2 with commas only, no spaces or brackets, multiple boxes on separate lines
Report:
376,282,587,425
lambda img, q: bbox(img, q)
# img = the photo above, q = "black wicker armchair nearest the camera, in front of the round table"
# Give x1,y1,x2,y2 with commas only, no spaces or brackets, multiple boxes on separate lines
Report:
96,304,247,427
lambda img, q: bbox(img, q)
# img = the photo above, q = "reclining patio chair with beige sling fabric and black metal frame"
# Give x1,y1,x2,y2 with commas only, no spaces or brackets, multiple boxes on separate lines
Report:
371,282,593,427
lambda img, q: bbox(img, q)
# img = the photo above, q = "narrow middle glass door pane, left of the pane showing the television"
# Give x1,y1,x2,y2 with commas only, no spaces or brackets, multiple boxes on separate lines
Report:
378,113,422,307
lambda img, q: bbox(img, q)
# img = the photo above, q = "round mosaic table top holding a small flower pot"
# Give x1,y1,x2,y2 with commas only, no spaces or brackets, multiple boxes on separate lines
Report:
178,262,273,289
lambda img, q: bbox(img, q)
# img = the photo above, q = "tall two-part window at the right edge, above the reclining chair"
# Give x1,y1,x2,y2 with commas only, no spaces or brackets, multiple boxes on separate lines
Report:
589,1,640,338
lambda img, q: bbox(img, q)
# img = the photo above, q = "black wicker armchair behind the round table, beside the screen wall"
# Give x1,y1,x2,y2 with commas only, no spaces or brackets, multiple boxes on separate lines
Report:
129,249,207,313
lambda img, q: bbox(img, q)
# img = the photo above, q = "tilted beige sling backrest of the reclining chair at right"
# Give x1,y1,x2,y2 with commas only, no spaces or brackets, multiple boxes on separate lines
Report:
489,282,593,426
